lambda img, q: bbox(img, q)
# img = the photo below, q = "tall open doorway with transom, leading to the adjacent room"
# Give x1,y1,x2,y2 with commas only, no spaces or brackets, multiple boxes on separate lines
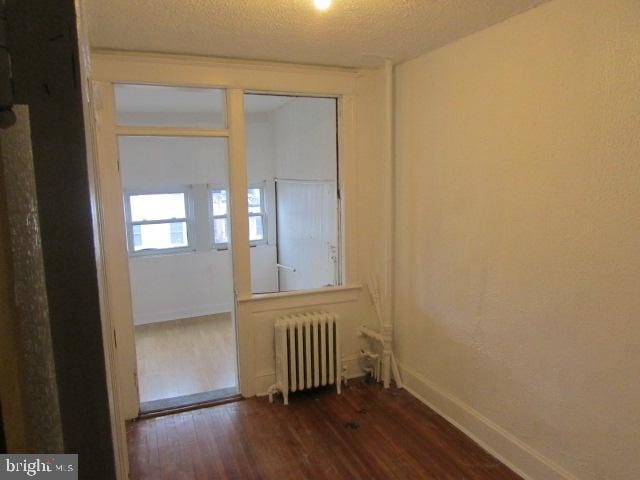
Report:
114,84,238,413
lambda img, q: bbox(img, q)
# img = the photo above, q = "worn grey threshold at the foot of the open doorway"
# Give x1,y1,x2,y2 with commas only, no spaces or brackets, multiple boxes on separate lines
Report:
138,387,242,418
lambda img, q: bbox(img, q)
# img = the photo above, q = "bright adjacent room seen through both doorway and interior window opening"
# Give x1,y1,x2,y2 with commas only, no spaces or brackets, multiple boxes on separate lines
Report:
114,84,340,414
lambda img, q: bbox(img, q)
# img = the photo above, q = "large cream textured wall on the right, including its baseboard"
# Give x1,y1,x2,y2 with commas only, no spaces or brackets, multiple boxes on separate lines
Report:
395,0,640,480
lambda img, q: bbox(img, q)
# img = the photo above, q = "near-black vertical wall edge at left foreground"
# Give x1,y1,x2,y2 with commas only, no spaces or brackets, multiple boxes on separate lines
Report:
7,0,116,472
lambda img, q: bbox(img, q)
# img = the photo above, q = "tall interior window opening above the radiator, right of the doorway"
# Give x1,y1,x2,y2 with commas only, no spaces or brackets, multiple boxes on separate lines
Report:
244,93,340,293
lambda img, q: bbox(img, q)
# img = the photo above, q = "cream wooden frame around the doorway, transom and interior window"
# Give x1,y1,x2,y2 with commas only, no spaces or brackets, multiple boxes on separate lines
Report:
91,52,359,419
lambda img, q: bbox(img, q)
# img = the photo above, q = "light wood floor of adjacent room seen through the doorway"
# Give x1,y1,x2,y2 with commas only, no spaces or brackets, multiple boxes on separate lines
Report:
135,313,236,402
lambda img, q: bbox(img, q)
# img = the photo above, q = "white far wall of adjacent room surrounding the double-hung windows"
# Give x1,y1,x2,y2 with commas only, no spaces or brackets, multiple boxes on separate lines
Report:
120,125,277,325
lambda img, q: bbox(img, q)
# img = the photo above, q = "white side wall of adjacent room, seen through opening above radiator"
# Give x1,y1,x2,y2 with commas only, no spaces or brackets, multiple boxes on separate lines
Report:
273,97,338,291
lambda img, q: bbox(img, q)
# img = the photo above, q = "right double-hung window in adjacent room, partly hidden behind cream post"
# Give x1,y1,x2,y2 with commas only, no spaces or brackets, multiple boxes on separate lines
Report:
210,186,267,249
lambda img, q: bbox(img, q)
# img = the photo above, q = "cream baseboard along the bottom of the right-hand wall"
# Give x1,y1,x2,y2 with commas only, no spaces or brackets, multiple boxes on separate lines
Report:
399,365,577,480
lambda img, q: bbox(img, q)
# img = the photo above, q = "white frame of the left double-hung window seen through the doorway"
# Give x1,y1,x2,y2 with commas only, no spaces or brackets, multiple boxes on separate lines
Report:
123,185,196,257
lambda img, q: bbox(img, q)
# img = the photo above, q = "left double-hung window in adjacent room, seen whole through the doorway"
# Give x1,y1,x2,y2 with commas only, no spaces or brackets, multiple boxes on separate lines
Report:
125,188,192,255
